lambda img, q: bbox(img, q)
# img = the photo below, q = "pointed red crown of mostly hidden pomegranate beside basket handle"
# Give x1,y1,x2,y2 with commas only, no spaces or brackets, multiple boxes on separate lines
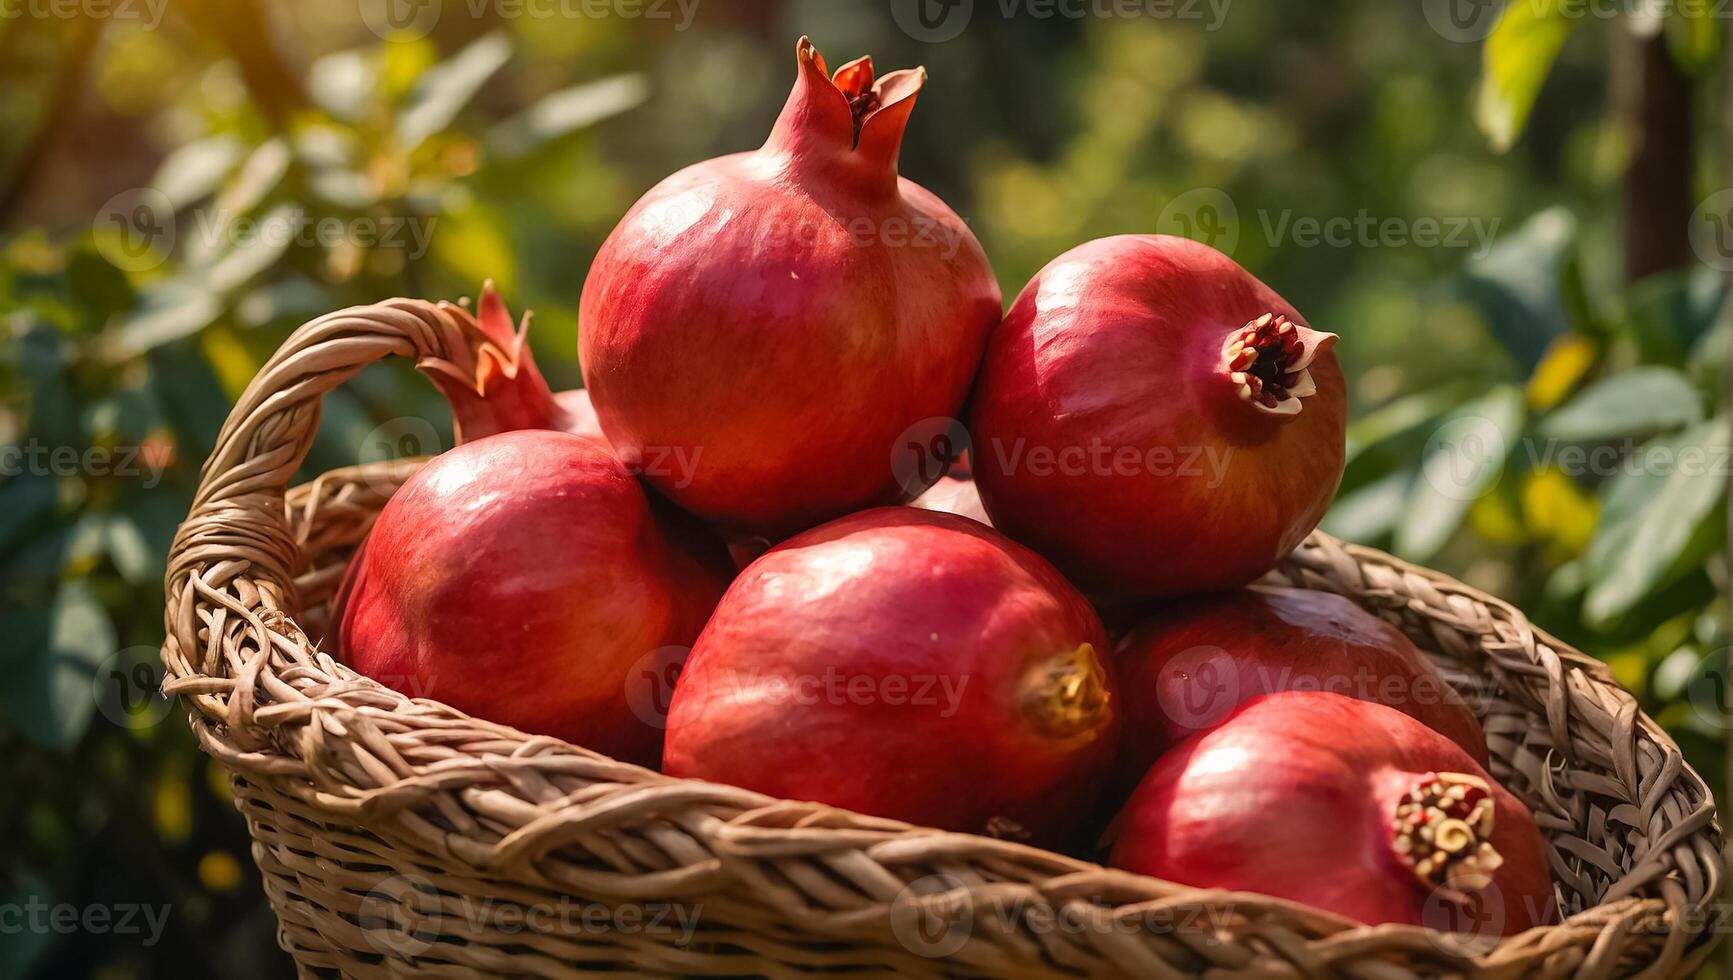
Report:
416,281,612,451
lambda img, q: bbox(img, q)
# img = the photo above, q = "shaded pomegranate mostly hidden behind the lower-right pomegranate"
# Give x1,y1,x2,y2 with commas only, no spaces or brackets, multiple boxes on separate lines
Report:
1114,586,1487,789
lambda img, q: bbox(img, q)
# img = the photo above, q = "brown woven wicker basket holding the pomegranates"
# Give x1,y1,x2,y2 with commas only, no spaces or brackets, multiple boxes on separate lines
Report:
163,300,1721,980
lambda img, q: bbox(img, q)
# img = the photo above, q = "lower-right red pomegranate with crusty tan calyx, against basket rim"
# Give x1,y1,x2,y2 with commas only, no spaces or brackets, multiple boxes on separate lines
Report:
1111,690,1555,937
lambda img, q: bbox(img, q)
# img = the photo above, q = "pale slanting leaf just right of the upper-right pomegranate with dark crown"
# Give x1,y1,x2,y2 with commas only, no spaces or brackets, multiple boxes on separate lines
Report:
1395,385,1523,560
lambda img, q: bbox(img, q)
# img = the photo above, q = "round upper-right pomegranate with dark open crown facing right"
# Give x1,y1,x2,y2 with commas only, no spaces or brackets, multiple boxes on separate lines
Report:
970,234,1347,598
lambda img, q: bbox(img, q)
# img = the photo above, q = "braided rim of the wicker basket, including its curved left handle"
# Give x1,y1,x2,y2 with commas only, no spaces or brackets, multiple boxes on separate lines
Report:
163,298,1721,970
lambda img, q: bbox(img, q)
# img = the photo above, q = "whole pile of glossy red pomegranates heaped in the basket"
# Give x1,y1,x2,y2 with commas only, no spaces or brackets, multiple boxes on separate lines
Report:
333,38,1555,935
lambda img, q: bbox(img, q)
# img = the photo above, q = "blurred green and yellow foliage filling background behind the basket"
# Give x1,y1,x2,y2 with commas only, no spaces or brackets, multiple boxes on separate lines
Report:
0,0,1733,980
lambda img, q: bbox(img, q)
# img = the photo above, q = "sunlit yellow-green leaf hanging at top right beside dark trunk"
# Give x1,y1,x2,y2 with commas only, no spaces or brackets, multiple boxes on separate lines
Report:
1475,0,1579,153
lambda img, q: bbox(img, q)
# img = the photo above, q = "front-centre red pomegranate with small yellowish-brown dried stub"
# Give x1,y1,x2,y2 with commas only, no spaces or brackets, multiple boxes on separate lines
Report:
662,506,1118,843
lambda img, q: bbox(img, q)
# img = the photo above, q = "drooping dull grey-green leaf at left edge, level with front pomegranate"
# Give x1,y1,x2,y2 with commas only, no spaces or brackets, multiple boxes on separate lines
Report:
5,581,116,749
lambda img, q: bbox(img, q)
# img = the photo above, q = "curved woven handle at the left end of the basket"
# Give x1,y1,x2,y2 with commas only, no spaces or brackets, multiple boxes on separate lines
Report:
163,298,480,689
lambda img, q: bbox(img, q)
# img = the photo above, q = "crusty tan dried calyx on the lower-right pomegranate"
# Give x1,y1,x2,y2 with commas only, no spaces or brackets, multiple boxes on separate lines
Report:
1390,772,1504,902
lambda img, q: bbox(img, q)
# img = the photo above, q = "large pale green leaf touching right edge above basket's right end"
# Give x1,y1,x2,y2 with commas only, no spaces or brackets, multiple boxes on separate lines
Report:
1582,416,1733,624
